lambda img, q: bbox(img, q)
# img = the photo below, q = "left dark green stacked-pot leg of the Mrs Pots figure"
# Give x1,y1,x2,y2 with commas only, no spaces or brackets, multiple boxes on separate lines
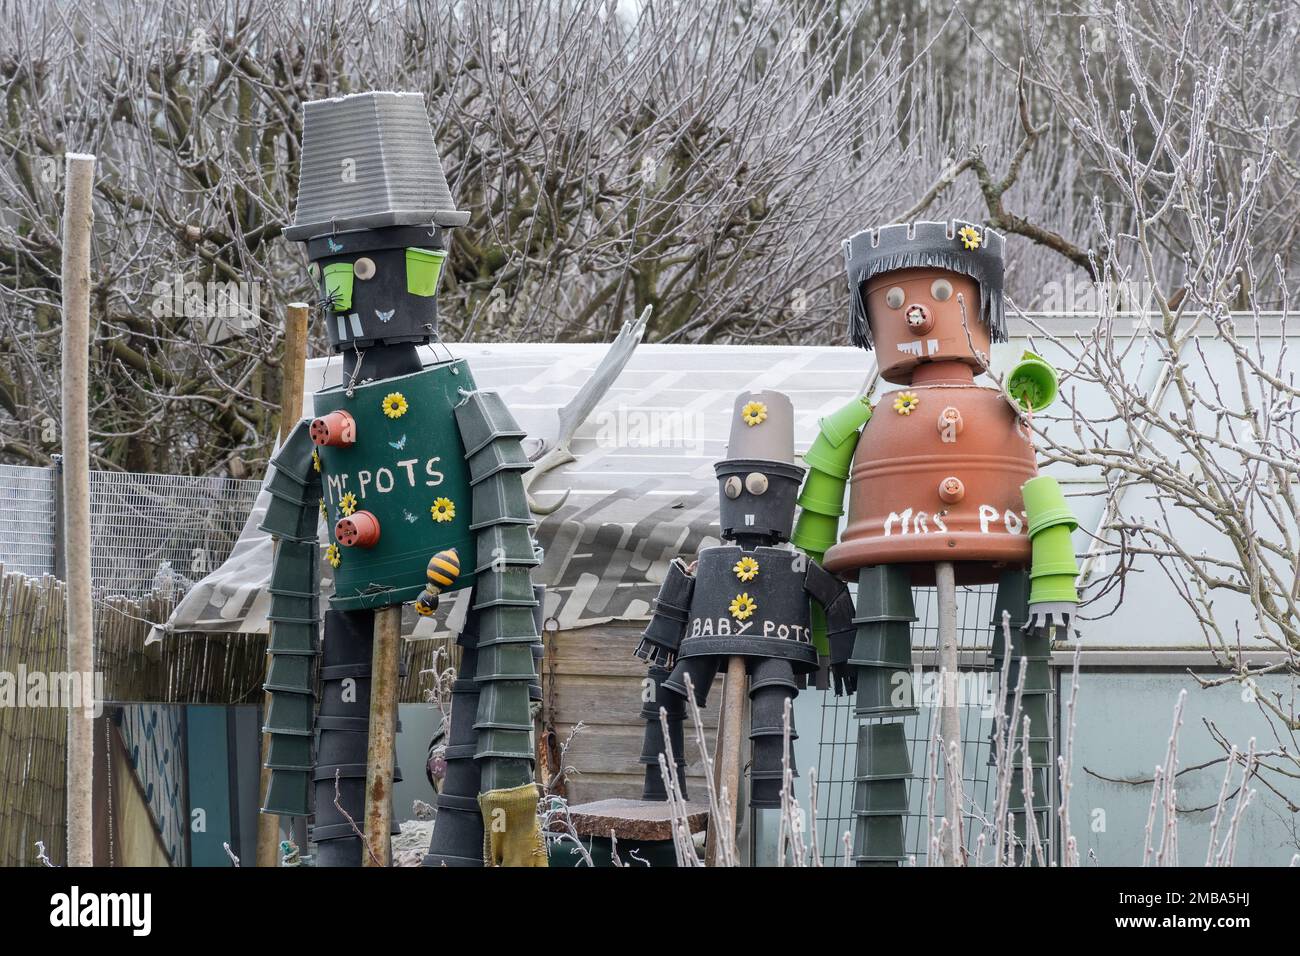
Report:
849,564,917,866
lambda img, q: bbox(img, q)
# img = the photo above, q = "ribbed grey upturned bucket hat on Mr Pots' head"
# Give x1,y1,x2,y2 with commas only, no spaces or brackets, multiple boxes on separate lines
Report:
285,91,469,241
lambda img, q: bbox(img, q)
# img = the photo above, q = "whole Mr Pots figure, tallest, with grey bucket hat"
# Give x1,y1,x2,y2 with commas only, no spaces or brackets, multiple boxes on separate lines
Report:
263,92,545,866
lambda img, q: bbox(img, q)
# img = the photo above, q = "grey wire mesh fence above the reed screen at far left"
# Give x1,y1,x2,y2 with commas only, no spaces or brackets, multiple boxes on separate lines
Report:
0,464,261,600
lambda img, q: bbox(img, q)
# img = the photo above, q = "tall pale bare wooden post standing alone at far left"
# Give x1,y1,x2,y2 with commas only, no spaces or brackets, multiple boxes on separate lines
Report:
62,152,95,866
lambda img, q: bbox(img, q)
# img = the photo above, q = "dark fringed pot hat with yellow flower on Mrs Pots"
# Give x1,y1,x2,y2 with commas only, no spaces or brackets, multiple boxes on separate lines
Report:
844,220,1006,349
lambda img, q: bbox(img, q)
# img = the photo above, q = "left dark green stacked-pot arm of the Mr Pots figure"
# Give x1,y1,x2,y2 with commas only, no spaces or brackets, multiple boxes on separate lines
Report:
259,421,321,817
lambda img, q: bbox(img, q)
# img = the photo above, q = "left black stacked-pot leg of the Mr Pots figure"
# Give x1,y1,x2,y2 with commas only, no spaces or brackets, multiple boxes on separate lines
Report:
311,610,402,866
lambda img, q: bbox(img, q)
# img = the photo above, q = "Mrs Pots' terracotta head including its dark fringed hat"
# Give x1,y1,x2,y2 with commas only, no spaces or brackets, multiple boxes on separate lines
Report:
844,221,1006,385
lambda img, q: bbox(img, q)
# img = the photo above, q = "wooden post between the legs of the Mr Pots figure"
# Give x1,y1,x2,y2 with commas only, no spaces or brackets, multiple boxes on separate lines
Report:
361,605,402,866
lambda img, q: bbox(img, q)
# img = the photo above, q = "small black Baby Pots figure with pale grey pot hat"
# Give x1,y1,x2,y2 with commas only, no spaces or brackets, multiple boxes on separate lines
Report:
636,392,853,808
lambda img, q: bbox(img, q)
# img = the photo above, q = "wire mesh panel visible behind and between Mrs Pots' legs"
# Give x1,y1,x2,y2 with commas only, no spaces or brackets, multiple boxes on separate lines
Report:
816,585,1057,866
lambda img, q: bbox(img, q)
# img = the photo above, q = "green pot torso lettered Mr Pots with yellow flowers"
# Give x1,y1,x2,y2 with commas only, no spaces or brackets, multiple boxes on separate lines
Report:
315,359,475,610
